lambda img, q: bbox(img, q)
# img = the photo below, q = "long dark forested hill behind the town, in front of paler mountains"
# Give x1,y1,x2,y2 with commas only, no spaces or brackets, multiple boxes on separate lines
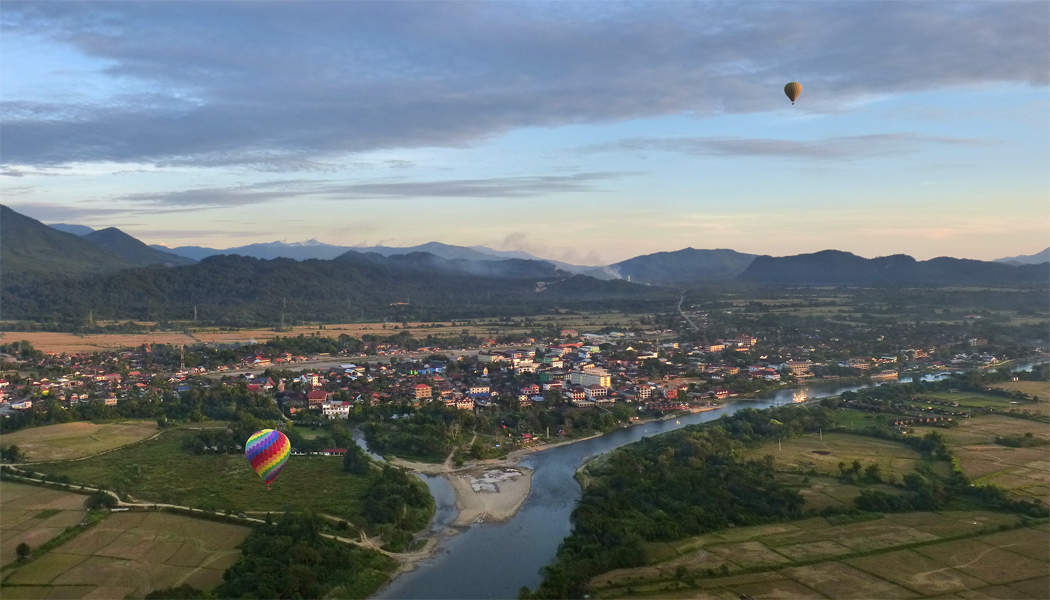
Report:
2,252,670,325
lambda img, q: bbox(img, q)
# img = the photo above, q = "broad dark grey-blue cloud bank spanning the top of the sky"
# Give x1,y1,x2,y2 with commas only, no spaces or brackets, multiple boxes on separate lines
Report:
0,2,1050,170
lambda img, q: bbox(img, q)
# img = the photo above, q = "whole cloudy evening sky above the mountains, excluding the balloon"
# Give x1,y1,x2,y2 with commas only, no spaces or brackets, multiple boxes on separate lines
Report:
0,0,1050,264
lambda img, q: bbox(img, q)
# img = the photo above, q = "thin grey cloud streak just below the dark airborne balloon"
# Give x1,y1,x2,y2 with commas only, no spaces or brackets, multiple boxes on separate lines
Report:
581,133,988,161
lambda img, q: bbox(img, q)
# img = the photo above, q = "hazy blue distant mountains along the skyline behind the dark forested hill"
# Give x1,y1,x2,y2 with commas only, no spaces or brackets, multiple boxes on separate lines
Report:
30,211,1050,288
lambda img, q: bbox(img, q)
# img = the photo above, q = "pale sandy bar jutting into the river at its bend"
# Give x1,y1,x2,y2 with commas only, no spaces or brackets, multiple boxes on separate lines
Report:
447,467,532,526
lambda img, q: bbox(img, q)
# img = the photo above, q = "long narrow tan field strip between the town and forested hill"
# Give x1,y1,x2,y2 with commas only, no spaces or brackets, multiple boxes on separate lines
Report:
0,312,645,353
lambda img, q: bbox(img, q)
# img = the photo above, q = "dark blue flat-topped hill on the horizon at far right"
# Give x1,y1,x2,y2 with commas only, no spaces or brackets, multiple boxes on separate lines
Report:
739,250,1050,286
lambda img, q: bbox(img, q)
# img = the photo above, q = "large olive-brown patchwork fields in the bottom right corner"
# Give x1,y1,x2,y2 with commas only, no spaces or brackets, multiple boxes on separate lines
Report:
591,511,1050,600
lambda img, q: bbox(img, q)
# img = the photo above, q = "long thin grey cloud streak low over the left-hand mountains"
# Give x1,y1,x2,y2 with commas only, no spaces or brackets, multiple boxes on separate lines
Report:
117,172,634,210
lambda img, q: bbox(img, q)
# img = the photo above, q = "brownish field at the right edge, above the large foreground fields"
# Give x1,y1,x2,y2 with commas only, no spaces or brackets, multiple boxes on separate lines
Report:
916,415,1050,504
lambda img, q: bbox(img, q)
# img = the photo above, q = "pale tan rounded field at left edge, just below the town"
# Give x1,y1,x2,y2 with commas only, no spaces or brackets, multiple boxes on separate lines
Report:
0,420,156,461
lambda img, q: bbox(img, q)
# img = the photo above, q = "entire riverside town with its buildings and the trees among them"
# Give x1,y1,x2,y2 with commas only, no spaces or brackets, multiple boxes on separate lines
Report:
0,310,1042,461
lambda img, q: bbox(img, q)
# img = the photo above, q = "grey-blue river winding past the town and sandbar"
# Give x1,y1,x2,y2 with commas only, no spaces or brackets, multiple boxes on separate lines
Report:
377,365,1031,599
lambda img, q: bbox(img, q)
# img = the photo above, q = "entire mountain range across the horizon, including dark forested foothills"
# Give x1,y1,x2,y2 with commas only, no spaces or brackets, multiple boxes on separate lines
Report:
0,206,1050,325
